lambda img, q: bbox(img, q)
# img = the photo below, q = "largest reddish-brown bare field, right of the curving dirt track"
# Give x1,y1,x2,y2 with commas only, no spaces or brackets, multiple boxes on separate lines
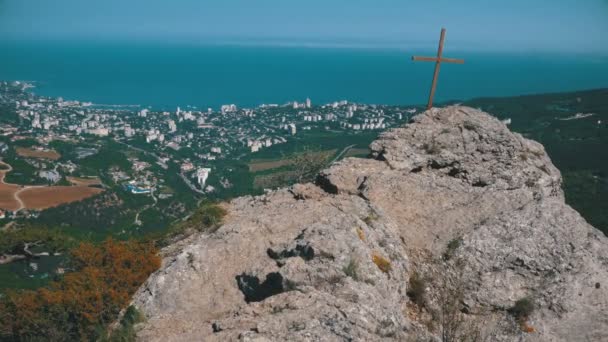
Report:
19,186,103,210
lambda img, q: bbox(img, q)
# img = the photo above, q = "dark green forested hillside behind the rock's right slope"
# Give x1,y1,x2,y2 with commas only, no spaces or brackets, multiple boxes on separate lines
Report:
464,88,608,235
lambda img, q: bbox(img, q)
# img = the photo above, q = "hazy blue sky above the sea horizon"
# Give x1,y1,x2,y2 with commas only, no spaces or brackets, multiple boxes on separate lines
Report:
0,0,608,52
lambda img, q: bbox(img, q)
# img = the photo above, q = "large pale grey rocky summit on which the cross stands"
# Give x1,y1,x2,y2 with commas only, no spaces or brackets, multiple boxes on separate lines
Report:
133,106,608,342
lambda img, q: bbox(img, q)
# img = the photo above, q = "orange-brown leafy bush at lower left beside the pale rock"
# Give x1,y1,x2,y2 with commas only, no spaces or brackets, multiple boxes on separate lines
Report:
0,239,160,341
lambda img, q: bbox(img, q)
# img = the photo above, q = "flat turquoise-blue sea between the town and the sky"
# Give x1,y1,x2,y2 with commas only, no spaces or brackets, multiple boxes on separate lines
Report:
0,41,608,108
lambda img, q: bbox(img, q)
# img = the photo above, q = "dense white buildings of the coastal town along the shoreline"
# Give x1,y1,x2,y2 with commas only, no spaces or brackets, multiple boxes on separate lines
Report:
0,82,416,207
